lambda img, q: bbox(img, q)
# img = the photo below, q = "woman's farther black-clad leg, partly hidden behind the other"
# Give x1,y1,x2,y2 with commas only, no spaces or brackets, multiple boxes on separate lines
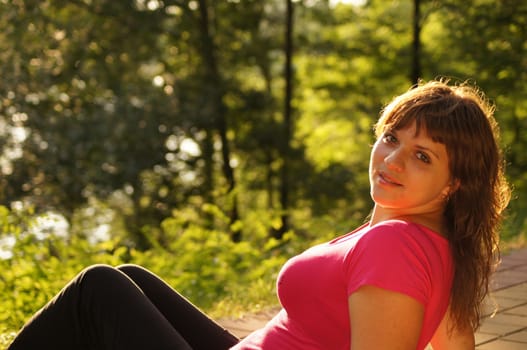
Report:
117,265,239,350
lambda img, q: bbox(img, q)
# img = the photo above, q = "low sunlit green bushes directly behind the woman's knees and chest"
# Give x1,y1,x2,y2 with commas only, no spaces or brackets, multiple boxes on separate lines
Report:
0,206,308,348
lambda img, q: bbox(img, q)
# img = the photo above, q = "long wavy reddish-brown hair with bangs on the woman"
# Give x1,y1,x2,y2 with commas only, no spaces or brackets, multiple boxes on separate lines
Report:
375,80,510,330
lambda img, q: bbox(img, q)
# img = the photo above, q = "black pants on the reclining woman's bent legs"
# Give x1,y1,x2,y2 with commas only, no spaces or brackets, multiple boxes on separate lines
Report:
8,265,238,350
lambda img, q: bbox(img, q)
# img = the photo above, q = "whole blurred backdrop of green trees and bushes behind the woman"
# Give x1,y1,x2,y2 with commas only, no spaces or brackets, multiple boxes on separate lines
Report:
0,0,527,344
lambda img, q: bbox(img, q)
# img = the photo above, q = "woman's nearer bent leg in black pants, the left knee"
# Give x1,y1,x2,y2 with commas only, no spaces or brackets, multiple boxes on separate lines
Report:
8,265,194,350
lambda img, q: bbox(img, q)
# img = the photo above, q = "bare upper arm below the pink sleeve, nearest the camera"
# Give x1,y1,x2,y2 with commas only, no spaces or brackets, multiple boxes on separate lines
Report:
348,286,424,350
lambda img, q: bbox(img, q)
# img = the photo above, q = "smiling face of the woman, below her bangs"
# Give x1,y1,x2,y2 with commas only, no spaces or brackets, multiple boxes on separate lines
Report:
369,122,452,216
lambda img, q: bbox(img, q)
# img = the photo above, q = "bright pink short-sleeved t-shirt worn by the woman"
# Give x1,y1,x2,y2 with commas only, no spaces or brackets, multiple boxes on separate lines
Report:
232,220,453,350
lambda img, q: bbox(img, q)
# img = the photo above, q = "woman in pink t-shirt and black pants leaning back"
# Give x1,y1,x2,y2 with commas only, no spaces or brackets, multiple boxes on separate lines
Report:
9,81,509,350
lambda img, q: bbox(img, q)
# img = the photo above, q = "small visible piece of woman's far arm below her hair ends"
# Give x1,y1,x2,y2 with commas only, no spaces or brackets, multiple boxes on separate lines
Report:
430,304,475,350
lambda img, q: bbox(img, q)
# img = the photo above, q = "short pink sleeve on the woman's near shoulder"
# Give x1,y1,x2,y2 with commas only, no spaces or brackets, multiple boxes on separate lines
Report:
345,221,431,305
